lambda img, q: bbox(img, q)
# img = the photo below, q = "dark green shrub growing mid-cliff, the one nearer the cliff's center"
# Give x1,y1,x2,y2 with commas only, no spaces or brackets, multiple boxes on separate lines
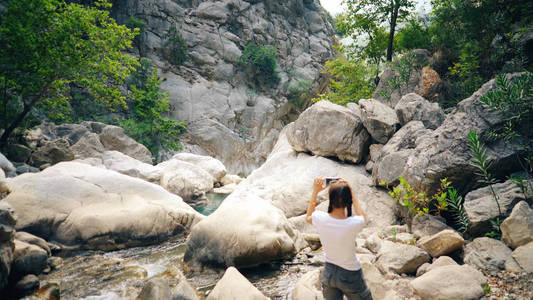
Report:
239,42,280,87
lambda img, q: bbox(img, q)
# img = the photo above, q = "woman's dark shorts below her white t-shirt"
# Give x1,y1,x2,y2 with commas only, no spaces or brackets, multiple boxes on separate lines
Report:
320,262,372,300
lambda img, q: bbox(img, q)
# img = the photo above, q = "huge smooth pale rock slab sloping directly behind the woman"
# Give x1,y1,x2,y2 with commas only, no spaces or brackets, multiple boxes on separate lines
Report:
225,125,395,226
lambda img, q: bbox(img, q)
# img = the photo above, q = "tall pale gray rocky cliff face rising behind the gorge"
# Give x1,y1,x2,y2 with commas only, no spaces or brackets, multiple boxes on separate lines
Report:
108,0,336,173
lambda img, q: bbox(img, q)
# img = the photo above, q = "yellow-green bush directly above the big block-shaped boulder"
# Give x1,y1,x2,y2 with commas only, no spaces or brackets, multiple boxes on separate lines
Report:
313,57,375,105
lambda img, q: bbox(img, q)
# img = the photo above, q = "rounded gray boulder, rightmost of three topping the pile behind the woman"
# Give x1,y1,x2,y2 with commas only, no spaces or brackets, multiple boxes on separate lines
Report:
394,93,445,129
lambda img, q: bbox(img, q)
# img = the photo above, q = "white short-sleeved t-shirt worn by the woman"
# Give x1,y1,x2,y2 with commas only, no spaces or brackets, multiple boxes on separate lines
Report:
311,210,365,271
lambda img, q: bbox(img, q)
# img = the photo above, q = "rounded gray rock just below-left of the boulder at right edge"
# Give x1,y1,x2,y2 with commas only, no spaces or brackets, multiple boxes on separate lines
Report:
463,237,511,270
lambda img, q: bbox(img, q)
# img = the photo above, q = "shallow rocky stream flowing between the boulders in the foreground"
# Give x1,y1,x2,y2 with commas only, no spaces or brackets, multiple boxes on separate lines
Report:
31,194,320,300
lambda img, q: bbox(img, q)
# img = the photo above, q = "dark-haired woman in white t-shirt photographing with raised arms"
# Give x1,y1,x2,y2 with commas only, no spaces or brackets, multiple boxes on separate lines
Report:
307,178,372,300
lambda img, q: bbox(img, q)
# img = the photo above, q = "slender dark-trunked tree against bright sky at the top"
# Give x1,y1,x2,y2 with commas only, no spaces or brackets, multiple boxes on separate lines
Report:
343,0,414,61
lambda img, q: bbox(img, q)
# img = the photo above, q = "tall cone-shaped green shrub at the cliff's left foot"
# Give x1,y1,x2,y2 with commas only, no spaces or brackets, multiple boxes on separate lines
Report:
119,59,185,157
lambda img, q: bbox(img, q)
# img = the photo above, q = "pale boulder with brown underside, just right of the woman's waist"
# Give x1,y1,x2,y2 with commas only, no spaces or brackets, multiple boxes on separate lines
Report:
376,241,430,274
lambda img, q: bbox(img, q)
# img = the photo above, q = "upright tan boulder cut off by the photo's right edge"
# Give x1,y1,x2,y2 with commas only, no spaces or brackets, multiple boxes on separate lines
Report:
500,201,533,249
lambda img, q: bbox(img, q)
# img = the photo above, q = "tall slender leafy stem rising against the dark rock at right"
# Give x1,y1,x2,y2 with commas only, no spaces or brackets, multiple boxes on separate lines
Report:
467,130,502,216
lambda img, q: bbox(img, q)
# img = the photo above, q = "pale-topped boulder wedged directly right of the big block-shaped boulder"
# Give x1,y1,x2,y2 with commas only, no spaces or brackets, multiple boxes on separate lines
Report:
359,99,400,144
